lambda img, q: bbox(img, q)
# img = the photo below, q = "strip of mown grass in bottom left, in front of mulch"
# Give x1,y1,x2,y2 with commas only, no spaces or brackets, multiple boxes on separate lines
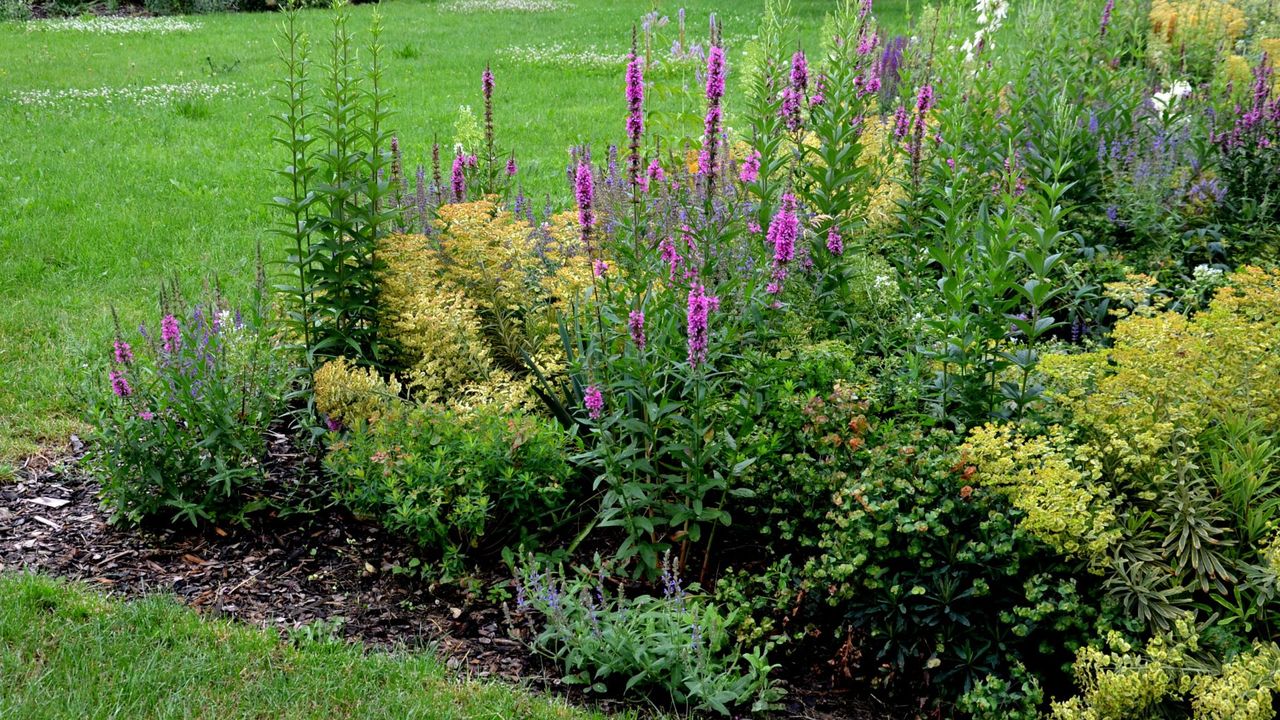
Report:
0,574,614,720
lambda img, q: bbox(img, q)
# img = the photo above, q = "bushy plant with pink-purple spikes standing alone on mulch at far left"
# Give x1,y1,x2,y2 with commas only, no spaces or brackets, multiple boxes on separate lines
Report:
88,278,292,524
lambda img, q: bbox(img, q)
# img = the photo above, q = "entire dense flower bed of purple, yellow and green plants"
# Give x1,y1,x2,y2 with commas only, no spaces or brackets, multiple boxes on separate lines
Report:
85,0,1280,720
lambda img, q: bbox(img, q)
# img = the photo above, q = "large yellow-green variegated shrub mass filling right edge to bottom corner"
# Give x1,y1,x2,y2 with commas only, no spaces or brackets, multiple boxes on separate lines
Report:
966,268,1280,719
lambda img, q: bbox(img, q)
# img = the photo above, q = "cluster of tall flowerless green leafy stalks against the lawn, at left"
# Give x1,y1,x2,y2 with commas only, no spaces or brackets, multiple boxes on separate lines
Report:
273,4,396,368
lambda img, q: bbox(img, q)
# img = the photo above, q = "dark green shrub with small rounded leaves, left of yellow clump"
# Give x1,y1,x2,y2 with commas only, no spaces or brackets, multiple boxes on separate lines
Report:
804,423,1096,698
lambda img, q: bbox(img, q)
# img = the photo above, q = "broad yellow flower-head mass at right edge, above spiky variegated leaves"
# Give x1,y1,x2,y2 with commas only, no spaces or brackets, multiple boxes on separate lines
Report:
1039,268,1280,482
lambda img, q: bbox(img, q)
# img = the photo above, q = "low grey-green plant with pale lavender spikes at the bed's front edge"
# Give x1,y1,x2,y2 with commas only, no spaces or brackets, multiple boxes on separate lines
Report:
516,557,782,716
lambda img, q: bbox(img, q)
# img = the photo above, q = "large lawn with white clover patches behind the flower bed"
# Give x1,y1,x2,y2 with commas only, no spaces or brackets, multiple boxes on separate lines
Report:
0,0,905,458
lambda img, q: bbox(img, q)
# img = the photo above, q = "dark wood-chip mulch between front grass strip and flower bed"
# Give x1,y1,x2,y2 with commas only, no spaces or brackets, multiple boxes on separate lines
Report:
0,436,904,720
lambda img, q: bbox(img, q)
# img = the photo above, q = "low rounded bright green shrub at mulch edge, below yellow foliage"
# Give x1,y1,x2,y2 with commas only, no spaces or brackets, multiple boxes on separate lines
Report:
325,397,570,573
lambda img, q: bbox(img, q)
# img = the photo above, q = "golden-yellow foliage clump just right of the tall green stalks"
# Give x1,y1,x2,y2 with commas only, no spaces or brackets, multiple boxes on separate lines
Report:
379,200,590,409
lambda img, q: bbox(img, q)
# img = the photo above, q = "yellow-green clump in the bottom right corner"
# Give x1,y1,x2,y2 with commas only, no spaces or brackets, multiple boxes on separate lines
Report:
1052,619,1280,720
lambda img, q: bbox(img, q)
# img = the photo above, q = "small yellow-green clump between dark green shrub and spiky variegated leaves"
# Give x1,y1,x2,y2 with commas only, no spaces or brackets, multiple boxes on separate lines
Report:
964,424,1120,565
